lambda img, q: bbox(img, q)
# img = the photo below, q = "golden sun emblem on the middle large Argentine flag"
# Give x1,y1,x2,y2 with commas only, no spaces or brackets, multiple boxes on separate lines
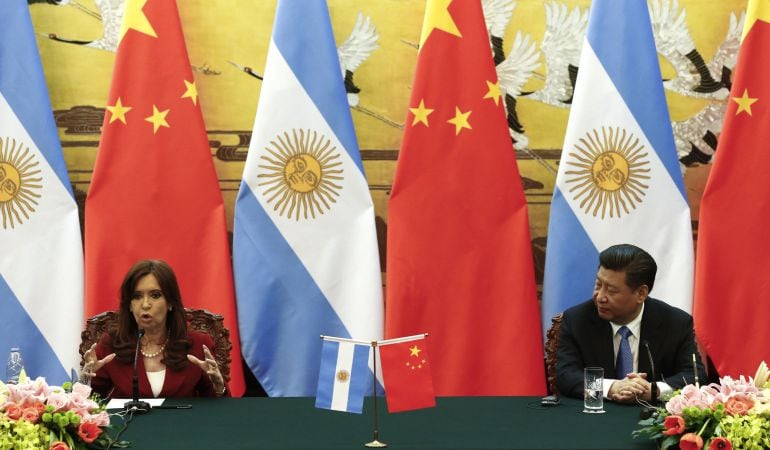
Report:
257,129,343,220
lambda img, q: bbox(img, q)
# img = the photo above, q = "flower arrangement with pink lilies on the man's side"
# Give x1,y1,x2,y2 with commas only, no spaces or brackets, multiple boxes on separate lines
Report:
633,361,770,450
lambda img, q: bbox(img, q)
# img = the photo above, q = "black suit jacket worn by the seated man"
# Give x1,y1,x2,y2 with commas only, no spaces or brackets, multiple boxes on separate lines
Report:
556,297,706,398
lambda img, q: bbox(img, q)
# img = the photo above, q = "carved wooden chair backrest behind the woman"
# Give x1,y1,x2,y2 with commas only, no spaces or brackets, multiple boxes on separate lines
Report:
80,308,233,383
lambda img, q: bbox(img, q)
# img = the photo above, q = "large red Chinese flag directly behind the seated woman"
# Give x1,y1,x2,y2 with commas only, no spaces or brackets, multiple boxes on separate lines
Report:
86,0,244,395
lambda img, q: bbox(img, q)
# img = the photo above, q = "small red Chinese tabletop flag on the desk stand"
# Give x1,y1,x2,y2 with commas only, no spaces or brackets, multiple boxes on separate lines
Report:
378,335,436,413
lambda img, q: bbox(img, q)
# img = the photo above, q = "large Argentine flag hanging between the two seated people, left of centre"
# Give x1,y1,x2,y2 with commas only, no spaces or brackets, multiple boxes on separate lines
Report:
233,0,383,396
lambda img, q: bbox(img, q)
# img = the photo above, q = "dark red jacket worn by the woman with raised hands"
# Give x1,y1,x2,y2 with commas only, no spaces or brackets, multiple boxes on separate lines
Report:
91,331,216,398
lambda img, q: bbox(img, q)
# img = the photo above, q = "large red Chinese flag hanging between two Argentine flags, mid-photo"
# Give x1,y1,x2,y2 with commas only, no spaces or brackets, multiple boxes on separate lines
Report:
385,0,545,396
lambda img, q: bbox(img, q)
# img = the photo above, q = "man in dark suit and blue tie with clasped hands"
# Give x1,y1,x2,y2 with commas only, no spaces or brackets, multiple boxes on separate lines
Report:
556,244,706,403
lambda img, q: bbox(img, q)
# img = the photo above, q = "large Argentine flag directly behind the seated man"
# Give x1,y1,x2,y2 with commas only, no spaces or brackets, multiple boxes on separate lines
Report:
542,0,693,330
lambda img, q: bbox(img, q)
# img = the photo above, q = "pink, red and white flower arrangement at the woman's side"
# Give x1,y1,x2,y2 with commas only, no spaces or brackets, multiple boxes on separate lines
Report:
0,378,128,450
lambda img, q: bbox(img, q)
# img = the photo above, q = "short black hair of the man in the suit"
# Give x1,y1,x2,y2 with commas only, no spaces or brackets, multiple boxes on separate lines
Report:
599,244,658,291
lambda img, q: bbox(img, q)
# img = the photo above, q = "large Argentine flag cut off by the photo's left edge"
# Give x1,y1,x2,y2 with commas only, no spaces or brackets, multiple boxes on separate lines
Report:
0,0,83,383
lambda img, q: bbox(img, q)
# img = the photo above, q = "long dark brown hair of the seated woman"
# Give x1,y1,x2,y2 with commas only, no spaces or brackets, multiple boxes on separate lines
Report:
109,259,192,370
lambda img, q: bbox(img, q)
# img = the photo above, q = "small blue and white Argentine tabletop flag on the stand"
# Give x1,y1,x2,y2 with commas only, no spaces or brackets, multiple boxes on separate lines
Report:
315,336,372,414
